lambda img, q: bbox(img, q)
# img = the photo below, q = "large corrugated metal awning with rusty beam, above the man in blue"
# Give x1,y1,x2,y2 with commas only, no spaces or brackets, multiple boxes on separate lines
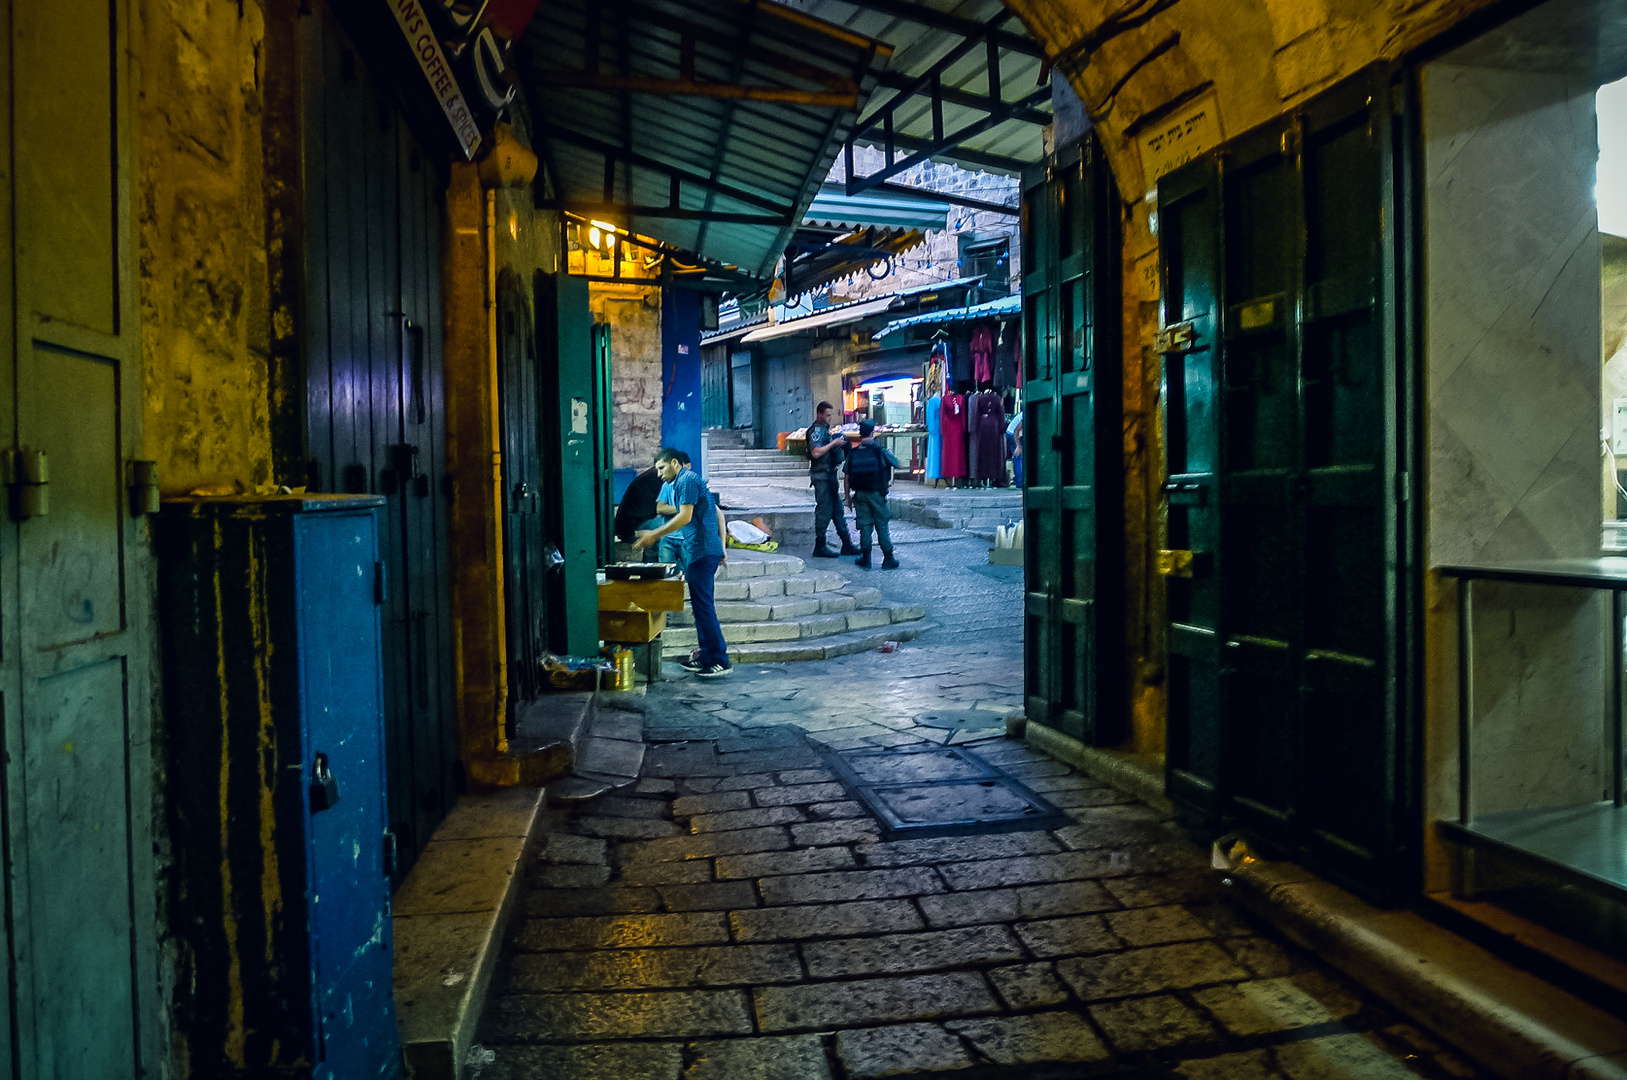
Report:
516,0,892,278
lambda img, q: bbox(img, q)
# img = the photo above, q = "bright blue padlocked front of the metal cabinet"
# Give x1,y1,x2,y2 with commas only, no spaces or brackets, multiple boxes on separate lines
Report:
294,514,400,1080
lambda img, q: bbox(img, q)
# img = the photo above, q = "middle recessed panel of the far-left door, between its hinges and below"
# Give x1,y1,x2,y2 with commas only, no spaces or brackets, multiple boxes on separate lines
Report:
18,345,127,649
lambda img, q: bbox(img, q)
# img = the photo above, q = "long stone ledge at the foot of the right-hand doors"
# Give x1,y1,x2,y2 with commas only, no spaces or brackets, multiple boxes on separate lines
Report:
1027,721,1627,1080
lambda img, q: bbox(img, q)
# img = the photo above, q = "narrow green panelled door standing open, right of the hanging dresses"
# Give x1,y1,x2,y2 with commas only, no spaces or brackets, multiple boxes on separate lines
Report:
1023,138,1126,745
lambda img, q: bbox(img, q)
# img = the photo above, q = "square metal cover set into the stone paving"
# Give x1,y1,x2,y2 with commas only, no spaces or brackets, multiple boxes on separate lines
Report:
825,747,1067,836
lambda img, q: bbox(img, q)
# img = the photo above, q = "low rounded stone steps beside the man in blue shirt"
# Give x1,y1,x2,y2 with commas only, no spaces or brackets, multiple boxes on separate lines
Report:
662,550,931,664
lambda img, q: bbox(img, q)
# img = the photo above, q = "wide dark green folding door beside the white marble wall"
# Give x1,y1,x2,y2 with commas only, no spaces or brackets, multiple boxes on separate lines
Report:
1158,70,1411,895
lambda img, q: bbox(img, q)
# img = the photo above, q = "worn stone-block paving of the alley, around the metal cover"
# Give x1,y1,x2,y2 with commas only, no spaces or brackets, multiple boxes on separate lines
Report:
470,529,1476,1080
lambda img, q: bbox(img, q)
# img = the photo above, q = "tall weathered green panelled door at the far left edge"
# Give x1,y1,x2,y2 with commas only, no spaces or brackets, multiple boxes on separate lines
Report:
0,0,164,1078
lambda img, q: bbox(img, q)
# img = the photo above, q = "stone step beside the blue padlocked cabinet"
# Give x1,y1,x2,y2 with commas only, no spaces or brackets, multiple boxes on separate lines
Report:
392,787,543,1080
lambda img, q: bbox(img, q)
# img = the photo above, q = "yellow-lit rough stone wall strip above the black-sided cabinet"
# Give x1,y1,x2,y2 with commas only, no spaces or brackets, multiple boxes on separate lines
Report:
132,0,273,491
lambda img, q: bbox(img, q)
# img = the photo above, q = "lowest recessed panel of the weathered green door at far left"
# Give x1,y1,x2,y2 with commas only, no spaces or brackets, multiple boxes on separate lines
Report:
23,657,138,1077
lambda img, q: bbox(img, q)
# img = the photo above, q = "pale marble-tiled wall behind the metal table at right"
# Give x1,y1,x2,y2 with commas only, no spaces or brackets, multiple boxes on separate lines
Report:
1424,63,1607,817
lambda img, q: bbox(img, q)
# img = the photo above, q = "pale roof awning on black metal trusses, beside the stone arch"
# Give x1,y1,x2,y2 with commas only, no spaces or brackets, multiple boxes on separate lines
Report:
799,0,1053,194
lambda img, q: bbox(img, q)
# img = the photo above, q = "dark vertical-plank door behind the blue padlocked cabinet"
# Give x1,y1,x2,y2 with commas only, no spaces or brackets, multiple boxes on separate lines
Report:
301,7,460,873
